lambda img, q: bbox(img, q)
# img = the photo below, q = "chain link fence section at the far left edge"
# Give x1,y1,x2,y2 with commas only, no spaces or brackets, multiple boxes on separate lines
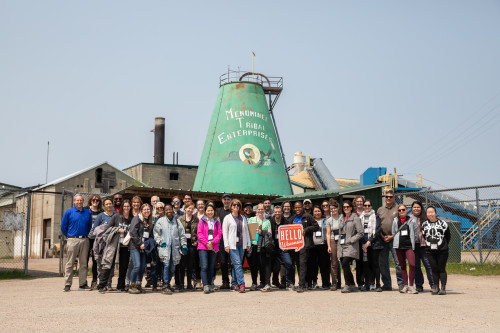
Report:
0,188,31,274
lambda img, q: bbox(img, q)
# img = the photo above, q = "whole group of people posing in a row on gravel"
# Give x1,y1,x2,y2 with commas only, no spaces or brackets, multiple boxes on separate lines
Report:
61,191,450,295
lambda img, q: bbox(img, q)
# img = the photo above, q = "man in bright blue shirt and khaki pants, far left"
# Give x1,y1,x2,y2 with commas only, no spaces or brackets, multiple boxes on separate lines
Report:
61,194,92,291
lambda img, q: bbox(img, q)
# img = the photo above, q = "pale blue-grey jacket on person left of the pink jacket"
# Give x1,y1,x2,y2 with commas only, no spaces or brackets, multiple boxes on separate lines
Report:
153,216,186,265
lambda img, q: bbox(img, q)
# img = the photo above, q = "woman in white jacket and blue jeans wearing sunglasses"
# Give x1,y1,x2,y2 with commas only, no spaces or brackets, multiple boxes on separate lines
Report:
222,199,252,293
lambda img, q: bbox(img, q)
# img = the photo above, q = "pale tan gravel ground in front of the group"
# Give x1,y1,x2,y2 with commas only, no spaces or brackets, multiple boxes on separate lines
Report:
0,260,500,332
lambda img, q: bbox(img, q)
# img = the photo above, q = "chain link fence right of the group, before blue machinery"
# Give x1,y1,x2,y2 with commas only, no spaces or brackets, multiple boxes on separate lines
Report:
396,185,500,264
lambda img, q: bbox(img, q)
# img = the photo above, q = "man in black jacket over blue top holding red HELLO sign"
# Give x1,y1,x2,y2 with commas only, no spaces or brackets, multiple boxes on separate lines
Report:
289,201,319,293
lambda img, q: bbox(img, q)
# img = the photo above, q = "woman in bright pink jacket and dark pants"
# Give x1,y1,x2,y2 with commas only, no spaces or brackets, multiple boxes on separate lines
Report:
197,204,222,294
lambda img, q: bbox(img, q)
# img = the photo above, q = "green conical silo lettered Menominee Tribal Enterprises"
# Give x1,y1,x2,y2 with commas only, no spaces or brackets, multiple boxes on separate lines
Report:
193,73,292,195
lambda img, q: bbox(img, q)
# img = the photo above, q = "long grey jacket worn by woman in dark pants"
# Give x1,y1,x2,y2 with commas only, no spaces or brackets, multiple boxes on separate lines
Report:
337,214,364,259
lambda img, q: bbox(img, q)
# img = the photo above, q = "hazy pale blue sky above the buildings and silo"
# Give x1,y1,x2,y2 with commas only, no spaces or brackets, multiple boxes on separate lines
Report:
0,0,500,187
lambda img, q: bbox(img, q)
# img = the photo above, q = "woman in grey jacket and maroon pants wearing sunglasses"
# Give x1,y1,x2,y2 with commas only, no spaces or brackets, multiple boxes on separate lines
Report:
392,204,418,294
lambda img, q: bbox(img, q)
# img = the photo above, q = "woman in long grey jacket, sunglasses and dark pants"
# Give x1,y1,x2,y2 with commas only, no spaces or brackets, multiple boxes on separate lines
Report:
337,200,363,293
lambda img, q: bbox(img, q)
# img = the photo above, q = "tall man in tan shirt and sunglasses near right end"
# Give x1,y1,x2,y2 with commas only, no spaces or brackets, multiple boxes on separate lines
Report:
377,190,403,291
